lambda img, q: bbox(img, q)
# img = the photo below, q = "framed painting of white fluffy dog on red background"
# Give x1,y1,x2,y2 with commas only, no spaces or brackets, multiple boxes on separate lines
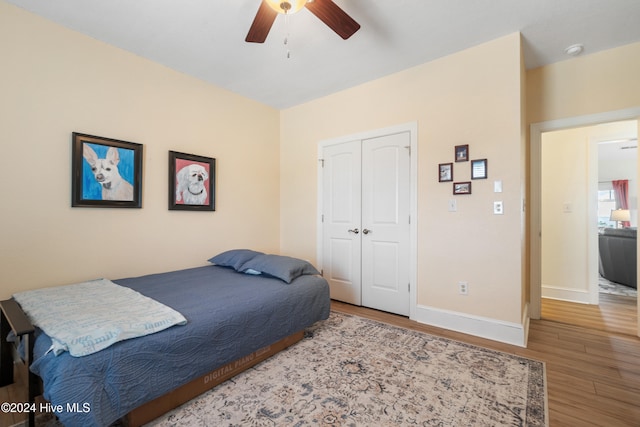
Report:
169,151,216,211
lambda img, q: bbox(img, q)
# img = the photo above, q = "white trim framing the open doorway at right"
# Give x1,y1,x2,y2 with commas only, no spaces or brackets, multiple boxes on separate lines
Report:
529,107,640,320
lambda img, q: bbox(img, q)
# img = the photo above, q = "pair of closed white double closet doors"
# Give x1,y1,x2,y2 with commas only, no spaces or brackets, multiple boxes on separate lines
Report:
318,124,417,316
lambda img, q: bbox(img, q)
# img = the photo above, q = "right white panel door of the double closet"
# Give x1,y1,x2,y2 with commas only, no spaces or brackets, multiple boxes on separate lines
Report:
361,132,410,316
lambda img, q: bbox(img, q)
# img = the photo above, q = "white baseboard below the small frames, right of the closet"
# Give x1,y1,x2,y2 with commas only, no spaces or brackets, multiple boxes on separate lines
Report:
412,305,529,348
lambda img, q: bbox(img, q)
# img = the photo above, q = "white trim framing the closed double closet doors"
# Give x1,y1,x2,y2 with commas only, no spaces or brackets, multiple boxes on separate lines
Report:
316,122,418,319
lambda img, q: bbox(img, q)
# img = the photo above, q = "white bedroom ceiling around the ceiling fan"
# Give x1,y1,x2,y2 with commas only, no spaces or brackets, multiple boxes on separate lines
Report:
6,0,640,109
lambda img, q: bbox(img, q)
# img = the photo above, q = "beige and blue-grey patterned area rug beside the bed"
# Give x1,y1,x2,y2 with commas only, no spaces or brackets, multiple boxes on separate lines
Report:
148,312,548,427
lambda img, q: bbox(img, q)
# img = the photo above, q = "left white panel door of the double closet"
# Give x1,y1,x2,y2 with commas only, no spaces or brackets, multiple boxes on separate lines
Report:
322,140,362,305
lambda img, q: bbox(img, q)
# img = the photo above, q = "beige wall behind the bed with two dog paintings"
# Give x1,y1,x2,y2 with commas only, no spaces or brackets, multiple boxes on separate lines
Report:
0,1,280,298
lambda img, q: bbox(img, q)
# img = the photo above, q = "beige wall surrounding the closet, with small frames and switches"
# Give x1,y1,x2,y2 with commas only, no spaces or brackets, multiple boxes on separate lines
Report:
280,34,524,323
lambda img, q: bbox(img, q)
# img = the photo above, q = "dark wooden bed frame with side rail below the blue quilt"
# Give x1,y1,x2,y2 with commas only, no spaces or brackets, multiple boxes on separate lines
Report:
0,299,304,427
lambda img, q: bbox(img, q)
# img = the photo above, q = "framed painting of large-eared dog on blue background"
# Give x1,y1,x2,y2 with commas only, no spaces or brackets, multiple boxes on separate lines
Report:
71,132,142,208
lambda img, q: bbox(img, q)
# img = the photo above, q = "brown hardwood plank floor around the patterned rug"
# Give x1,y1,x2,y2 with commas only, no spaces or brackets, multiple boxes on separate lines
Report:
0,301,640,427
